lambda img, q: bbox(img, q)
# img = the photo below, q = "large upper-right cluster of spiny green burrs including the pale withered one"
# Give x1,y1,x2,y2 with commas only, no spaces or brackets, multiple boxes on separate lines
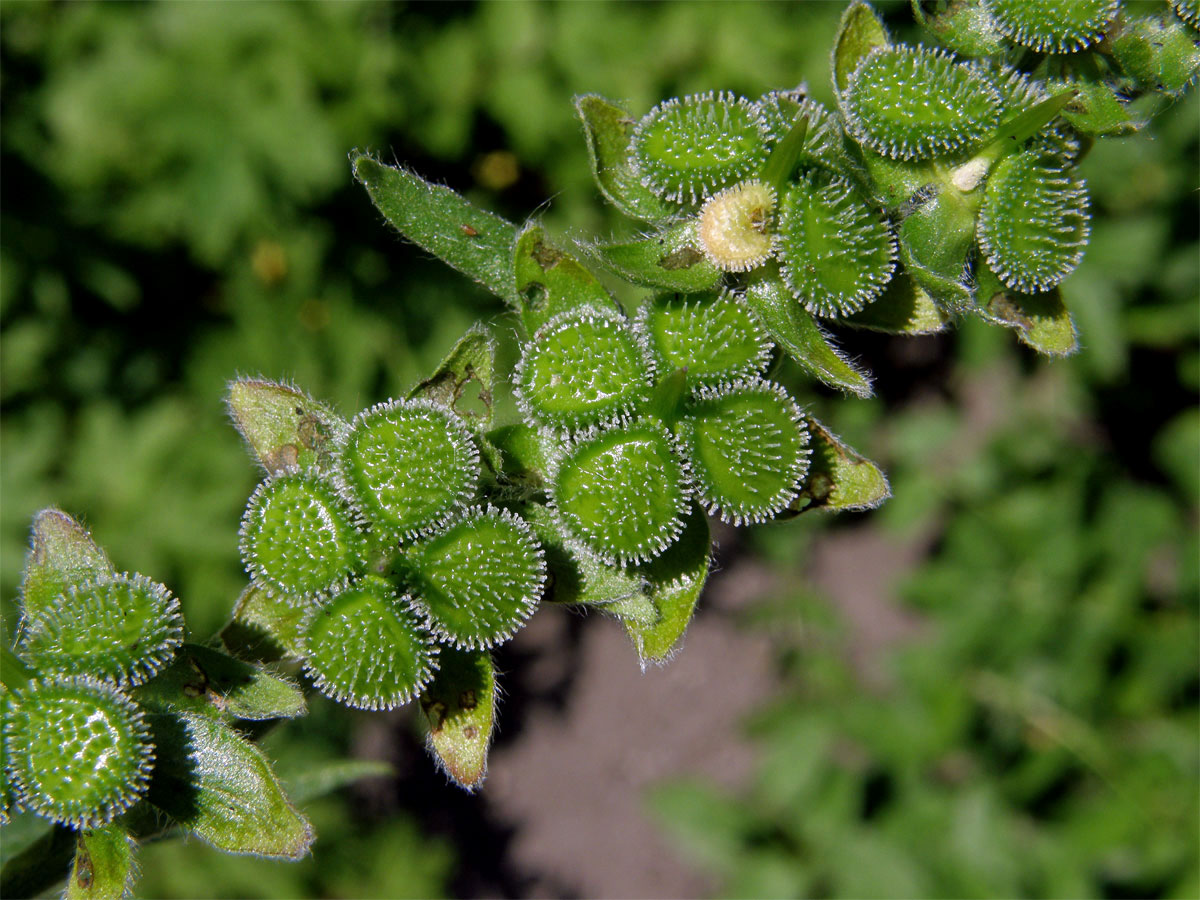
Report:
595,0,1200,353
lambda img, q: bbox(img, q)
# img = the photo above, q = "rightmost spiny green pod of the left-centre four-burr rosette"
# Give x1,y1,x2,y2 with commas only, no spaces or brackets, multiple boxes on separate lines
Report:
404,509,546,649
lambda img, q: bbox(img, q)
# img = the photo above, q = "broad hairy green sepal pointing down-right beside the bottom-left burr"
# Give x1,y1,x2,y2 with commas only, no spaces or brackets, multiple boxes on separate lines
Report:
149,712,314,859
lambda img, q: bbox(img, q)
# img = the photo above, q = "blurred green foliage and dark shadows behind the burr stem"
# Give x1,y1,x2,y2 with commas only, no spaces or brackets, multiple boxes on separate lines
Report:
0,1,1200,896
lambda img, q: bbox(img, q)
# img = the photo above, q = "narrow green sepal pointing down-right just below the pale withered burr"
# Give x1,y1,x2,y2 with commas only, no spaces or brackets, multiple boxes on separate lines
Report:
745,276,880,397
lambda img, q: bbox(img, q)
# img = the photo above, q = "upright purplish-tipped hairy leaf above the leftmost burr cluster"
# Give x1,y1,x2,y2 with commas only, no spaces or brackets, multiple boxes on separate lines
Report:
20,508,113,617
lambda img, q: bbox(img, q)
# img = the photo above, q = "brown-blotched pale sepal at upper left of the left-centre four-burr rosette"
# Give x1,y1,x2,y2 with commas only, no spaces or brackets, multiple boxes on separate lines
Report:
226,378,346,475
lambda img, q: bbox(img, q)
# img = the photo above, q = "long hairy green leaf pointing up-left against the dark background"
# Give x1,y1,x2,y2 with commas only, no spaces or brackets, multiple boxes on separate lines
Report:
350,152,517,306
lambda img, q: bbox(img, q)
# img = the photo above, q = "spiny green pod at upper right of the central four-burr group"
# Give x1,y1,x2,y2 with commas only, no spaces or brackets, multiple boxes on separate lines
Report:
637,292,770,389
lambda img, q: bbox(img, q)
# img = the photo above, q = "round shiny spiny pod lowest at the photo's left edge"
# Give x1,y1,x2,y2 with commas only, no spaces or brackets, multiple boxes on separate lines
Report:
4,677,154,828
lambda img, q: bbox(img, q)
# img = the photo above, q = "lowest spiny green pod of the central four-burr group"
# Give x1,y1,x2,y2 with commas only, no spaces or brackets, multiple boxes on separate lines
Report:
551,421,689,564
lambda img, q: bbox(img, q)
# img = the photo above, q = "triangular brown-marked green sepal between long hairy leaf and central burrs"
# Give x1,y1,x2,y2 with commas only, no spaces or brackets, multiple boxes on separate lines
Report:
512,222,620,335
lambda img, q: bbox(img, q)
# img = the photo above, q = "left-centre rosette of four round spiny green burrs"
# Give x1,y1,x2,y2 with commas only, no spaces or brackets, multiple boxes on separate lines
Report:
234,393,546,709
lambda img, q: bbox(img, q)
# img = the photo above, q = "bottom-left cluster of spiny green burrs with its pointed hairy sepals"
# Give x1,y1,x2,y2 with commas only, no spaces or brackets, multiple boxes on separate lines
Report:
0,509,312,868
